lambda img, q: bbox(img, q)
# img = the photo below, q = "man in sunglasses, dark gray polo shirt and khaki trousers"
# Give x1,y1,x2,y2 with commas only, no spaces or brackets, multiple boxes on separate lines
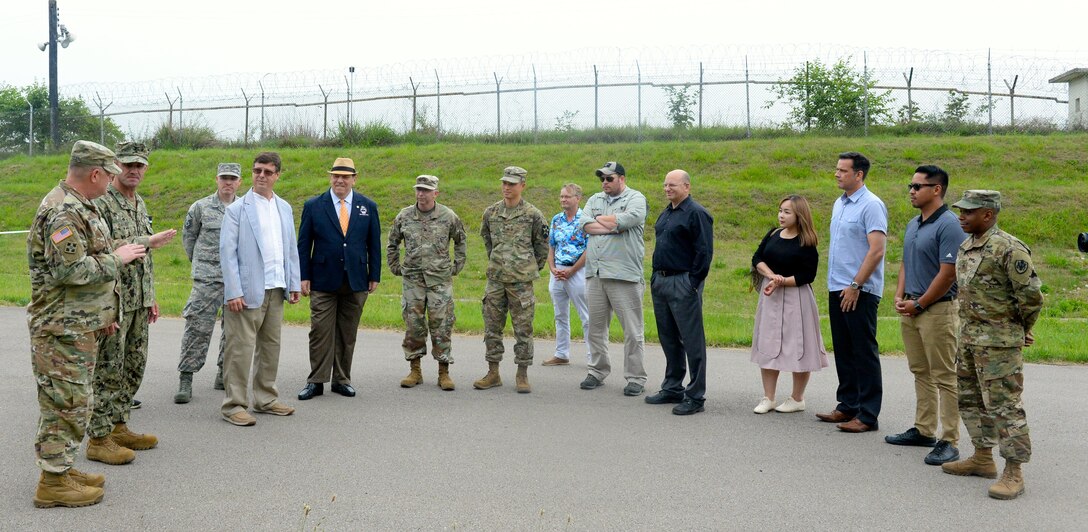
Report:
885,165,967,466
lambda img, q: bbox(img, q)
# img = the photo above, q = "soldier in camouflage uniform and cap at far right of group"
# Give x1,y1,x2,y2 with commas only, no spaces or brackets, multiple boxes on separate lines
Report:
941,190,1042,499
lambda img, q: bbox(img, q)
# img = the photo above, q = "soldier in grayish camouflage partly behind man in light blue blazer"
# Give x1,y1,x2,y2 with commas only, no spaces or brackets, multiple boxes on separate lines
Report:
174,162,242,404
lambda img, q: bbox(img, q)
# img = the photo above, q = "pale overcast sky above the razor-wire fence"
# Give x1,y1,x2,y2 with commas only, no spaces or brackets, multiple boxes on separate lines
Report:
0,0,1088,86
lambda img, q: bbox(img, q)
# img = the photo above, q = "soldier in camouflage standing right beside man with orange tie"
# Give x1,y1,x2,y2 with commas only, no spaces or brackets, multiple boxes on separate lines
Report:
385,175,467,392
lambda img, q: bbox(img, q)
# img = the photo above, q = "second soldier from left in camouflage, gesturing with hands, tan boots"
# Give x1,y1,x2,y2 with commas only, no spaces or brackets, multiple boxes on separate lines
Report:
87,143,177,465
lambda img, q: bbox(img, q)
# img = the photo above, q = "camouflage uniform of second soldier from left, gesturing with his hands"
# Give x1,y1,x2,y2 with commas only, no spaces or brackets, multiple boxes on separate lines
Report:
87,184,154,437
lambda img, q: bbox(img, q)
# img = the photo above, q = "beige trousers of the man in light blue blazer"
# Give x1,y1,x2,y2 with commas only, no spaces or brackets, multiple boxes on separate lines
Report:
222,288,283,416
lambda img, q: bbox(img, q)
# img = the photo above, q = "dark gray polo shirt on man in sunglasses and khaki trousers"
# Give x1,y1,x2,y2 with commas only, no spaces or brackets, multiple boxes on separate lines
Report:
903,206,967,297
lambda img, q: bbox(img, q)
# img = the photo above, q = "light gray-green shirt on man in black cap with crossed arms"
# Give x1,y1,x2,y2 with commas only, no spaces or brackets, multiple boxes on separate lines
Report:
578,187,647,283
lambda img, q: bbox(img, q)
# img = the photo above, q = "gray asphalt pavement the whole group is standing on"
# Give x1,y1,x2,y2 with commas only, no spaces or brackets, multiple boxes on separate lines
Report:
0,307,1088,531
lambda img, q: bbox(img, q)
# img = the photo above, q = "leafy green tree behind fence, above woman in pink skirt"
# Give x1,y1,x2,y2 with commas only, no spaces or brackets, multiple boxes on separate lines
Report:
767,58,891,129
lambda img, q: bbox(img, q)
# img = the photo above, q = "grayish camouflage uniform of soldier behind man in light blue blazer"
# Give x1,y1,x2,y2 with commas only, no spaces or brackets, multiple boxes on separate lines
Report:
177,193,227,373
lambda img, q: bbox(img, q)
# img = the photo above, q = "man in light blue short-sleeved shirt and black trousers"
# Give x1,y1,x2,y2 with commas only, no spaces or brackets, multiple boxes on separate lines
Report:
816,151,888,433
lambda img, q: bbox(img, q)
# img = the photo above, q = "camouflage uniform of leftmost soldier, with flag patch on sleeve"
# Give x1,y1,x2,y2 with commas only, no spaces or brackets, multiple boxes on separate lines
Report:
26,176,122,473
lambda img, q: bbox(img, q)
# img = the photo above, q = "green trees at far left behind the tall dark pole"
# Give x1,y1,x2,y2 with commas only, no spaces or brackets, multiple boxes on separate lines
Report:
0,85,124,152
